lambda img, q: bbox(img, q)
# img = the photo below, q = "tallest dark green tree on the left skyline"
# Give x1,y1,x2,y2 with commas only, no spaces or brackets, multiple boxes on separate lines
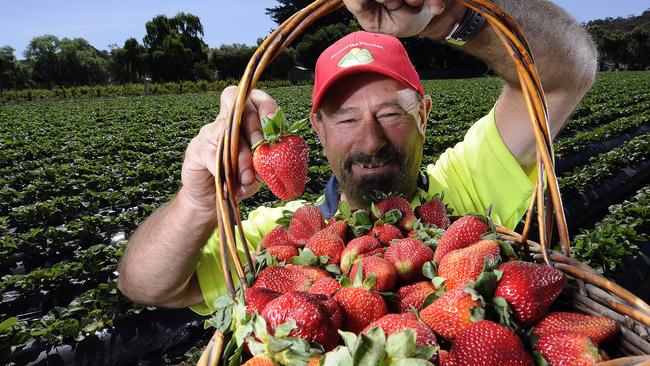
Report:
143,13,208,80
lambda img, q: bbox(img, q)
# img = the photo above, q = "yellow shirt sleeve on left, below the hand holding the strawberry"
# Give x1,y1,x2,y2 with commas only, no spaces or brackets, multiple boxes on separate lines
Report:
190,201,305,315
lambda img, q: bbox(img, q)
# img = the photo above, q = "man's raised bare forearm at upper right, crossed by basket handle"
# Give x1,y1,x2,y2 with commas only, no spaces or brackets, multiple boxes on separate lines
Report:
423,0,596,92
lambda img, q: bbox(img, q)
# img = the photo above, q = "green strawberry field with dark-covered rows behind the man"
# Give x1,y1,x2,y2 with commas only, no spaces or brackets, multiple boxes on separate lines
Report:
0,72,650,365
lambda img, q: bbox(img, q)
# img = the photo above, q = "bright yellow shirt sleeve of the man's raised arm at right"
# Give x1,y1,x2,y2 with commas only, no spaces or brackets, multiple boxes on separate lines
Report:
427,108,537,229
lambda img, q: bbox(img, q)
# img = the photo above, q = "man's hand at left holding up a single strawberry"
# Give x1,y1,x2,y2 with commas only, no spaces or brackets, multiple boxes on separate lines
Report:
181,86,278,215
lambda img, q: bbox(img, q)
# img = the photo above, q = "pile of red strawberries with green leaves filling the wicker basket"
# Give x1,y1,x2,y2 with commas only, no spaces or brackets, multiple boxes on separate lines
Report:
224,196,619,366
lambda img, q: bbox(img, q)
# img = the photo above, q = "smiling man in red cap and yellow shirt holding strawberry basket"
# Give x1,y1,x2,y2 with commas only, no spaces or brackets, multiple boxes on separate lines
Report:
120,0,596,314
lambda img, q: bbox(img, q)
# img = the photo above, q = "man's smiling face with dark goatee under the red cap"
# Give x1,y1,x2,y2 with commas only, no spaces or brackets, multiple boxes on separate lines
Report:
312,74,431,208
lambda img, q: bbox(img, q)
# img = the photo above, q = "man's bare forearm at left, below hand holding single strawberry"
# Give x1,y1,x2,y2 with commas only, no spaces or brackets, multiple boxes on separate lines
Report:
120,189,216,305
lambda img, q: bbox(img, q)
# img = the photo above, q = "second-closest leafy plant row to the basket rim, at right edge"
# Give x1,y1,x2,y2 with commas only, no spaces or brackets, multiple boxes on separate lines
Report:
558,134,650,195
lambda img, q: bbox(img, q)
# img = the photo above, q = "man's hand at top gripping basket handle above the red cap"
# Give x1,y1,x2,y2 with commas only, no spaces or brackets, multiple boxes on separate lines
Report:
343,0,455,37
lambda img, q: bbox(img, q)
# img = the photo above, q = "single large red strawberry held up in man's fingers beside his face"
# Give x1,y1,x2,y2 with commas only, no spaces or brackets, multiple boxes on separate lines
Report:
253,109,309,201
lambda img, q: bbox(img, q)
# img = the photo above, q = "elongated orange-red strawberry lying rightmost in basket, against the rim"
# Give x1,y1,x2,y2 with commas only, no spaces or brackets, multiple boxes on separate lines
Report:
533,312,619,346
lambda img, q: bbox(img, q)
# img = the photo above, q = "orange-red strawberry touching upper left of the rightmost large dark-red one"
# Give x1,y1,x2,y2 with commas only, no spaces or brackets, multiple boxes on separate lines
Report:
438,240,500,291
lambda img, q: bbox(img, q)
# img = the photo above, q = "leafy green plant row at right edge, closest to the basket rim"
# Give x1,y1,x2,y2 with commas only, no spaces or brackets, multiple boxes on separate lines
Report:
573,186,650,276
